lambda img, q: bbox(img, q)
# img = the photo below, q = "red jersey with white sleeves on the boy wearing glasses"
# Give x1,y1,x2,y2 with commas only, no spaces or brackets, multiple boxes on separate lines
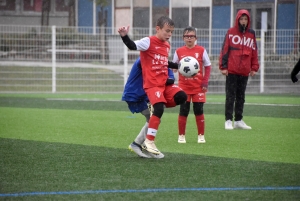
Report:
173,45,211,94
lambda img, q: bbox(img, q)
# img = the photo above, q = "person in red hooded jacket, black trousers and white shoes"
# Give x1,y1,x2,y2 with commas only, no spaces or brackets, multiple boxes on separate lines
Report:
219,10,259,130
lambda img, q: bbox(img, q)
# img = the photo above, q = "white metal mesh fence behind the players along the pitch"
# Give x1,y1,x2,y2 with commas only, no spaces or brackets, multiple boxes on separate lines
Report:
0,25,300,94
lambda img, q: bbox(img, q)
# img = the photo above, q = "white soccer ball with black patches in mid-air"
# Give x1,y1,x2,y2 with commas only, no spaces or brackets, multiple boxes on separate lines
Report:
178,56,200,77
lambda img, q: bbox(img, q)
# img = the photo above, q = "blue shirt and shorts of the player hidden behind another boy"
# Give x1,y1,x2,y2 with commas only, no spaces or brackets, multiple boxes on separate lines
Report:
122,58,175,113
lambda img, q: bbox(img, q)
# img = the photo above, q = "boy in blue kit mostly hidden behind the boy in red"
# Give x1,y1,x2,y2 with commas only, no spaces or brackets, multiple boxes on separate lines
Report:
122,58,176,158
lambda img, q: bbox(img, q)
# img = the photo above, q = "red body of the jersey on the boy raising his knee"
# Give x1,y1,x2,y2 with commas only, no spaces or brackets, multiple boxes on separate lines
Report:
140,36,170,89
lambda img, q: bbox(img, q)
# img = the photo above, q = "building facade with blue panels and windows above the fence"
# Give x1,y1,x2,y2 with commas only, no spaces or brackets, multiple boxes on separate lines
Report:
0,0,300,30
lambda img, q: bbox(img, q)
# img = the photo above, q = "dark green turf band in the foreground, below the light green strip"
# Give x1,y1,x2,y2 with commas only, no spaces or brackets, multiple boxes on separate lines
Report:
0,138,300,200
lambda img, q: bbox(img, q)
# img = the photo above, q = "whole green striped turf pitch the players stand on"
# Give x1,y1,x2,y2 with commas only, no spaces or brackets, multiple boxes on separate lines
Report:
0,94,300,200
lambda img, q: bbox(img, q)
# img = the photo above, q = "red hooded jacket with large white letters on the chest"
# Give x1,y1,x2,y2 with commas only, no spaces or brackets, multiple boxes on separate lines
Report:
219,10,259,76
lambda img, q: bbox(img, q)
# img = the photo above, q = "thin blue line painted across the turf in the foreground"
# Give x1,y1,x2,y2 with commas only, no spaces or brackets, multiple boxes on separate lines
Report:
0,186,300,197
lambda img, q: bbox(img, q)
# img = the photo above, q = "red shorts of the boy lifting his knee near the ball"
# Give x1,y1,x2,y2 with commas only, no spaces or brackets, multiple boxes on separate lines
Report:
145,84,182,107
